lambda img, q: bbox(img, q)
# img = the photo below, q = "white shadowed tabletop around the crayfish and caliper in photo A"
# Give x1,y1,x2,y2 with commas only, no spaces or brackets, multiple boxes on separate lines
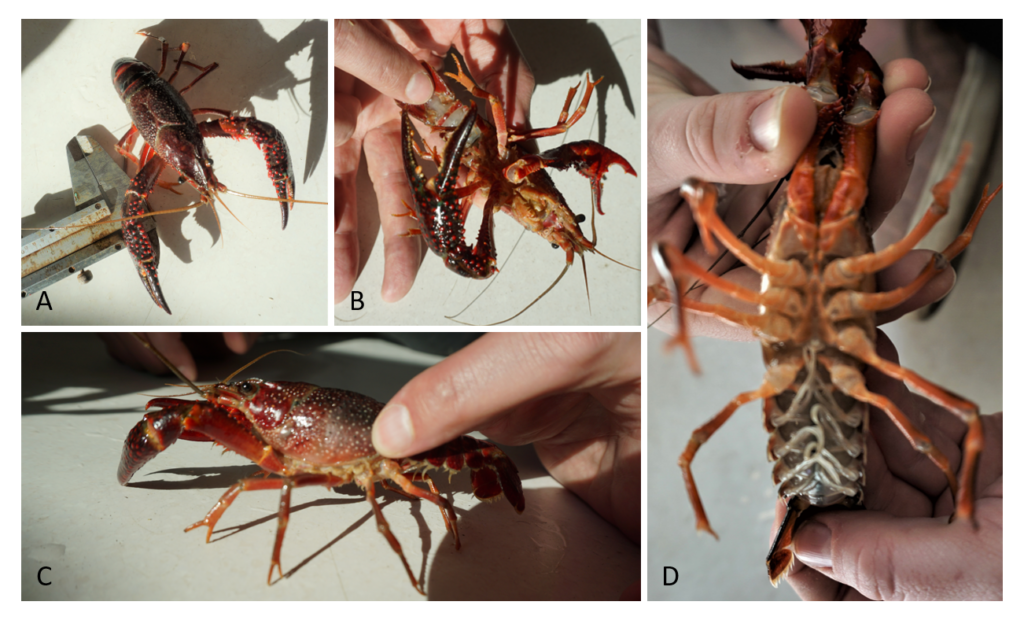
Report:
22,20,328,325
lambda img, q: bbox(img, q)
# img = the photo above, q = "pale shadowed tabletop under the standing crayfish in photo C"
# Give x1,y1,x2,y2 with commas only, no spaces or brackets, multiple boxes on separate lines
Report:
22,334,640,601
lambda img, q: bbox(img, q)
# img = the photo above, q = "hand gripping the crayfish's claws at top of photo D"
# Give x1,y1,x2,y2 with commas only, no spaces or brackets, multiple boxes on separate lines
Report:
647,20,942,340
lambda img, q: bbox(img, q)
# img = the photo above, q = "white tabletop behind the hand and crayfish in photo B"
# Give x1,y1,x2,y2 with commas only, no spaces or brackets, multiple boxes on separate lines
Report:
334,19,643,326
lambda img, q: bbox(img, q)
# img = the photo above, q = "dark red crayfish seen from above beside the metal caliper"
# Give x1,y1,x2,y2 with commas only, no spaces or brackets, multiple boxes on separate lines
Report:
111,33,296,315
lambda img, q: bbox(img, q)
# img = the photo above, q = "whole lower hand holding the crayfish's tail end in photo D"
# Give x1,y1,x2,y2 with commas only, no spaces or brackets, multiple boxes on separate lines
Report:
772,333,1002,601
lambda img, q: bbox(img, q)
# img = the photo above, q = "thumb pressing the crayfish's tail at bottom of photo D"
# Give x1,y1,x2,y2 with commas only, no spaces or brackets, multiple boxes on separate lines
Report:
794,511,1001,601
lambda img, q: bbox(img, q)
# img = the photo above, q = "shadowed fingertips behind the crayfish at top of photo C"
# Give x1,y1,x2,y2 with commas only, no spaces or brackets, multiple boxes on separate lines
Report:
99,332,259,381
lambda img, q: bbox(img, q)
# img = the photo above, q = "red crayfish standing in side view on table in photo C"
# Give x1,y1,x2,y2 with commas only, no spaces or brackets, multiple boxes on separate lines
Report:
118,337,525,594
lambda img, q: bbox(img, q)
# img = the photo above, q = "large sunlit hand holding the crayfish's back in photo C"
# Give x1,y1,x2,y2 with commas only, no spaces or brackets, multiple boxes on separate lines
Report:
373,333,641,544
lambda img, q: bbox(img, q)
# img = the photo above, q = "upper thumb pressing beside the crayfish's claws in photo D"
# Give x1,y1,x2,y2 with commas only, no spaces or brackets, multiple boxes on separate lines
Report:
647,86,817,196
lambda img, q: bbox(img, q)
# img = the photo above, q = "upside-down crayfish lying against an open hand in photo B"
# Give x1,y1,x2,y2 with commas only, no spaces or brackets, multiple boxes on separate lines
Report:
399,54,636,323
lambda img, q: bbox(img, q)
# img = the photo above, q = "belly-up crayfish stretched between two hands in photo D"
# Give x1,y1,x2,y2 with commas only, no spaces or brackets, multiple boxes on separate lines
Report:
653,19,1001,585
